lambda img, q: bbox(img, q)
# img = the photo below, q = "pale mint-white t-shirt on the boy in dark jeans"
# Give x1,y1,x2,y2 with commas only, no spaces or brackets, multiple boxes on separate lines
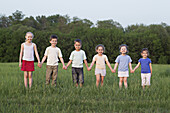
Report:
69,50,87,68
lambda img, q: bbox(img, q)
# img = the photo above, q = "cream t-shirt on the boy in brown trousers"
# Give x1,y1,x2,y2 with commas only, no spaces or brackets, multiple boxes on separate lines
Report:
44,46,62,66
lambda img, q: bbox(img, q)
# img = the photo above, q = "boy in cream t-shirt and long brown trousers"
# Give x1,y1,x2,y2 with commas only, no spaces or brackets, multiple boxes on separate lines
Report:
41,35,65,86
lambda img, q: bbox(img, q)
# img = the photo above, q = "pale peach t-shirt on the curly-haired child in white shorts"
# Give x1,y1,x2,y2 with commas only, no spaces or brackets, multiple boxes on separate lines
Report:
93,54,108,69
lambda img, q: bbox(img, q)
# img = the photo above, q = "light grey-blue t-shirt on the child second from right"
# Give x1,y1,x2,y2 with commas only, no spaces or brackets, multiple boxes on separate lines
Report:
115,55,132,71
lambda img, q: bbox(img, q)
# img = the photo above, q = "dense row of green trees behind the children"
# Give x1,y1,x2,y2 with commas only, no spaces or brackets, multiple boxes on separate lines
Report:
0,10,170,64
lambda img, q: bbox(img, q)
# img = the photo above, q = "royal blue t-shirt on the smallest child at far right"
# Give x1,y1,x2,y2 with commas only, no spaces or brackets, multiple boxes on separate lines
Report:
138,58,151,73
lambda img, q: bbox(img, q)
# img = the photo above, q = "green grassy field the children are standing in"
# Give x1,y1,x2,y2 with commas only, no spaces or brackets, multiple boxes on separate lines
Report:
0,63,170,113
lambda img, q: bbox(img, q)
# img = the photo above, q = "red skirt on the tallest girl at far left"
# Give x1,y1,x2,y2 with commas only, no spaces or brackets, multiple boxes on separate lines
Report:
21,60,35,71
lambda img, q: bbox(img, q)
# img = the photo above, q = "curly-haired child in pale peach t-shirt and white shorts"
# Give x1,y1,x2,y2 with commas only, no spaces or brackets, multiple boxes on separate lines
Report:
89,44,113,87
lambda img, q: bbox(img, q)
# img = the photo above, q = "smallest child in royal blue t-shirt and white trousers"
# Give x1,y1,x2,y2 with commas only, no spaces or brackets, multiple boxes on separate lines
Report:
133,48,152,90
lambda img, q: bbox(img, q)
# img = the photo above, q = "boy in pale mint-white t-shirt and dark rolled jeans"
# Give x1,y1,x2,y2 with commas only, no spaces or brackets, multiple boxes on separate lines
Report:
65,39,89,87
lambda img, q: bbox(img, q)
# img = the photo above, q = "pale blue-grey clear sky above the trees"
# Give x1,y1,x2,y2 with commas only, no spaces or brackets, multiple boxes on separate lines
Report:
0,0,170,28
